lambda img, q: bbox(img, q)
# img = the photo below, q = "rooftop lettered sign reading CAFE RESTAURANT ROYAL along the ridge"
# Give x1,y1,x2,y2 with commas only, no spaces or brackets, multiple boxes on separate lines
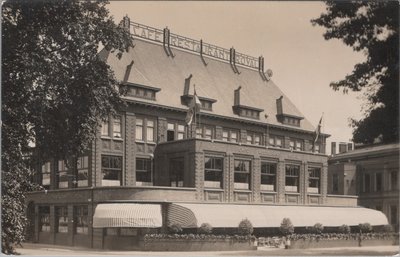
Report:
130,21,260,69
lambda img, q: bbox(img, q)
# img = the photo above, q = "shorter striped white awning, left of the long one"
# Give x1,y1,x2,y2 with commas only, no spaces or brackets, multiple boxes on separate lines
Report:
93,203,162,228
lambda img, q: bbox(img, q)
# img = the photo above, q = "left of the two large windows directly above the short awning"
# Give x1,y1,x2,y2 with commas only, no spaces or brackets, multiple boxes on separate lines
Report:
101,156,122,186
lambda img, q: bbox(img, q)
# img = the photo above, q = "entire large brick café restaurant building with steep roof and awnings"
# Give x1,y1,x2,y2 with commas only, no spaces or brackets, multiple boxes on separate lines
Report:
27,17,387,249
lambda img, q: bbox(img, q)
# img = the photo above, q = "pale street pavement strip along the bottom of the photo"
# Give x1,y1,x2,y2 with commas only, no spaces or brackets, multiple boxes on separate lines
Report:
17,243,400,257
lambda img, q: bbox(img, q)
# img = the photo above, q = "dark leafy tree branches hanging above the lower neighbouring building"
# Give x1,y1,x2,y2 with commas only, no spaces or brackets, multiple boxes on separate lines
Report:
311,0,399,144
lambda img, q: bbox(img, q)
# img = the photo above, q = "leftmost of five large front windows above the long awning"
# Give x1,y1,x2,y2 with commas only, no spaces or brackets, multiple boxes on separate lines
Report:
204,156,223,188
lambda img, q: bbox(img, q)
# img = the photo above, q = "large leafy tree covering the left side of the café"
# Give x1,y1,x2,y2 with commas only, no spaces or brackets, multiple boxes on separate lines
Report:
1,0,133,254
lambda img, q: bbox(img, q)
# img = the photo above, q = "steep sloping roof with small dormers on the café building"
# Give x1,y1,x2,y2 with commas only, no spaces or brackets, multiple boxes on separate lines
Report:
100,33,315,132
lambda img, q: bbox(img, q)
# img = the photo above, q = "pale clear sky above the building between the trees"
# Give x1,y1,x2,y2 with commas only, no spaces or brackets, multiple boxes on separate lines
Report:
108,1,365,154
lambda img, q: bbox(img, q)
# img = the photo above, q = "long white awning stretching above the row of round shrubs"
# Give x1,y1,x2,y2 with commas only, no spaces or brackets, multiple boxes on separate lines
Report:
167,203,388,228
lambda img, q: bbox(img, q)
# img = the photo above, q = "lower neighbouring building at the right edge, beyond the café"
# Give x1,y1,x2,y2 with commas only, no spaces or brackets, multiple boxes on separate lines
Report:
328,143,400,230
